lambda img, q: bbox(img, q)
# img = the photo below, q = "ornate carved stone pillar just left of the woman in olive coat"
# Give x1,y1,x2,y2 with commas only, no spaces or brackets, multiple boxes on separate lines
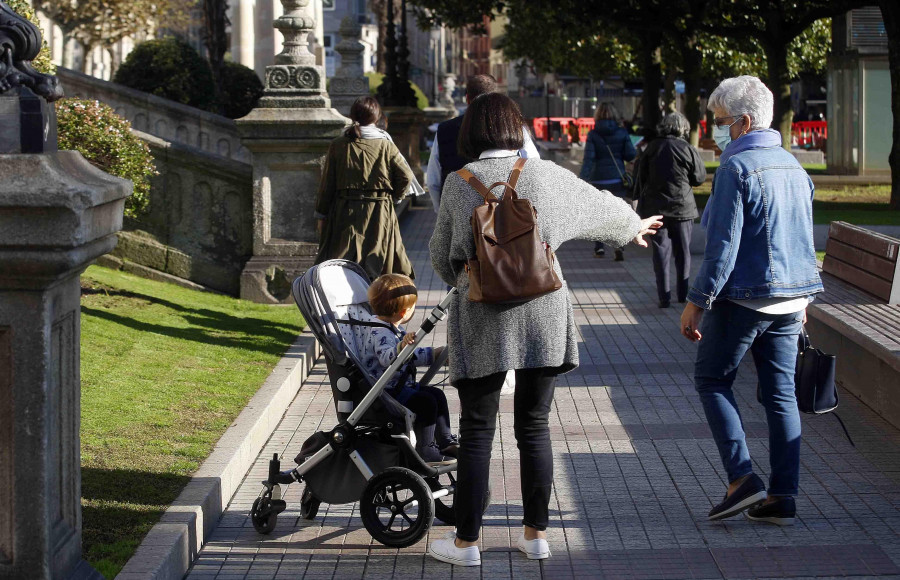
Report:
237,0,349,304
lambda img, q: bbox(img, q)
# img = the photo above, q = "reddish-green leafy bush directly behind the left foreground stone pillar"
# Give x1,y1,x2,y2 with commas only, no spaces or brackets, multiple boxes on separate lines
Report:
56,99,157,218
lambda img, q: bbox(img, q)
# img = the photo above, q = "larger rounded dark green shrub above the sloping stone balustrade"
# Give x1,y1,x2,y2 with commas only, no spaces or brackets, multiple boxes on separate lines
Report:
114,38,216,111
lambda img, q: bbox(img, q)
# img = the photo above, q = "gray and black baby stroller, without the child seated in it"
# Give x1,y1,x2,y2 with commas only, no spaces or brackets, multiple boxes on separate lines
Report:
250,260,488,547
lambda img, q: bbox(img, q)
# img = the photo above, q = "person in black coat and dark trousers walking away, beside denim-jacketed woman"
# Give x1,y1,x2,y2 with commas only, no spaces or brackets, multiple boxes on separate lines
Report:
635,112,706,308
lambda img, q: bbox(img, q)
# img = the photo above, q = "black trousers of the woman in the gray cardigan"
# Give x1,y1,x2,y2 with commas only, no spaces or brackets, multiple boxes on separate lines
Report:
453,368,556,542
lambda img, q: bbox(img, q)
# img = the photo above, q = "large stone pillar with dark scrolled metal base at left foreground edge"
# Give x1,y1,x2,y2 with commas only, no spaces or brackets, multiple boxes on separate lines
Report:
0,3,132,580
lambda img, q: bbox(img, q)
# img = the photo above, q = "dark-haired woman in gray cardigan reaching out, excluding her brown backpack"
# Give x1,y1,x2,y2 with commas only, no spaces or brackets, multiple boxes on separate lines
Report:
429,93,662,566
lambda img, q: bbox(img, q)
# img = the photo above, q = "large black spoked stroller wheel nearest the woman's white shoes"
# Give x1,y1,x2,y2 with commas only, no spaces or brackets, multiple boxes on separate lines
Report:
359,467,434,548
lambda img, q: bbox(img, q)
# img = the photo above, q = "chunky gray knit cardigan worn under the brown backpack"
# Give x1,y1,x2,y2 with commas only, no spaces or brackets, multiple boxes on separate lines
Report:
429,157,640,382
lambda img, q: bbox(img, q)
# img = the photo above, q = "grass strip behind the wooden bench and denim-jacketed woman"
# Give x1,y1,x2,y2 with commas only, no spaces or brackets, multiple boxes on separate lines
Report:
694,183,900,226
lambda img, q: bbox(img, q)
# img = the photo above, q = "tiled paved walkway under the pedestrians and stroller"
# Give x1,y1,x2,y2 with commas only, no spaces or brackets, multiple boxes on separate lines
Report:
188,209,900,580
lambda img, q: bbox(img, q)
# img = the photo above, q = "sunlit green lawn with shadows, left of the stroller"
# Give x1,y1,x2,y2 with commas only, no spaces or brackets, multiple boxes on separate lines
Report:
81,266,304,578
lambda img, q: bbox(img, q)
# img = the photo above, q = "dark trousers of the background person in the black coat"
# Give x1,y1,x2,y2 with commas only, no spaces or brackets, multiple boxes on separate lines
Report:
649,217,694,302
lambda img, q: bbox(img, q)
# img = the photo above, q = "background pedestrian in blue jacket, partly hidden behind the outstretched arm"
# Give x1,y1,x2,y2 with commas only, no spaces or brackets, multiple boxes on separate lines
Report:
578,103,637,262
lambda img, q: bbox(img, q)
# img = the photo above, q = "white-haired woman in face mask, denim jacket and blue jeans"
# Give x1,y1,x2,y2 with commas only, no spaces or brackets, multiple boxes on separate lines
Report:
681,76,824,525
